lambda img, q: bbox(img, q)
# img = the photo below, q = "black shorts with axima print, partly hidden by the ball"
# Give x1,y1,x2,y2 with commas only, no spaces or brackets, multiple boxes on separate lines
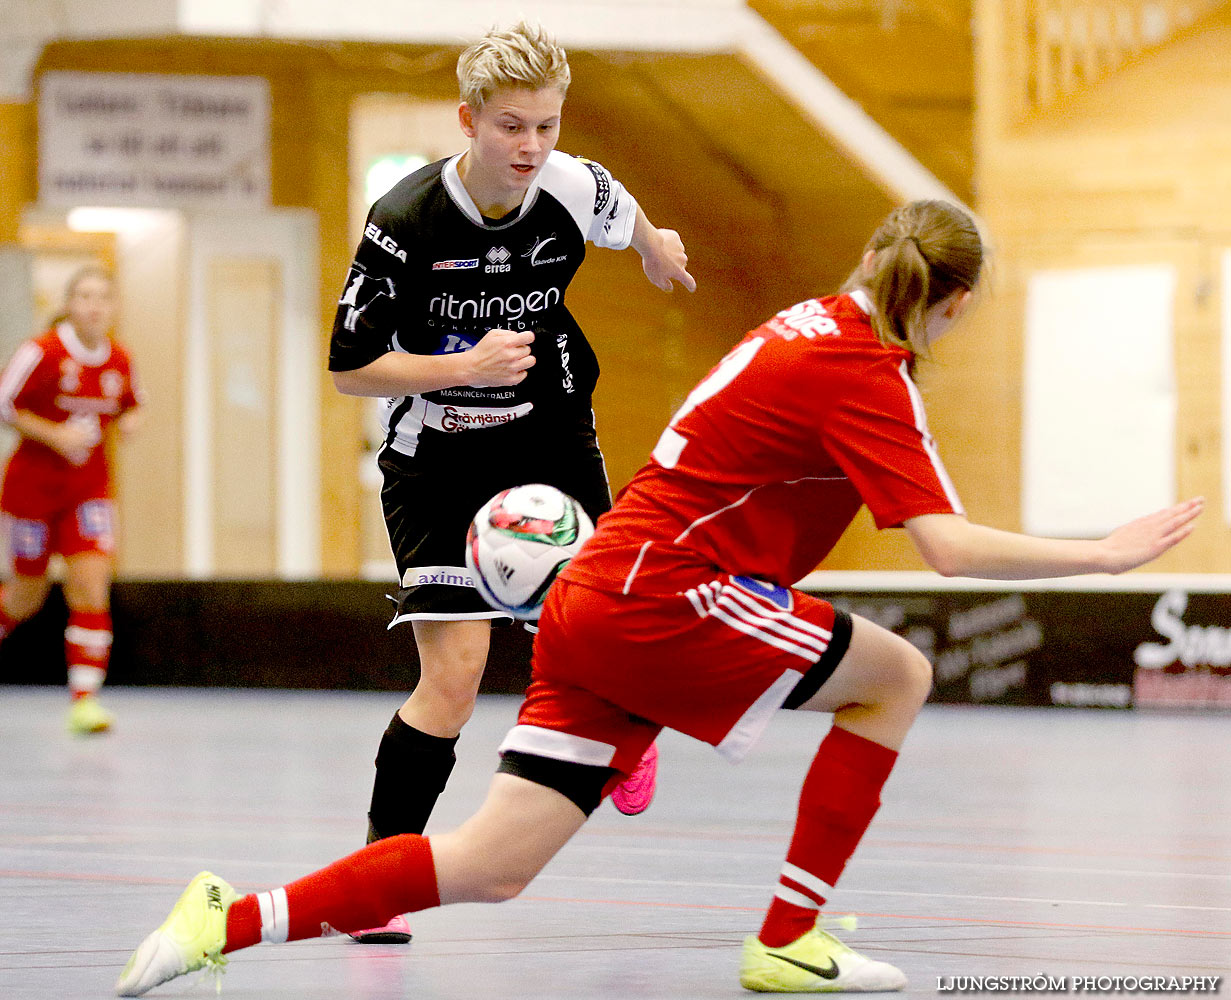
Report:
379,414,612,627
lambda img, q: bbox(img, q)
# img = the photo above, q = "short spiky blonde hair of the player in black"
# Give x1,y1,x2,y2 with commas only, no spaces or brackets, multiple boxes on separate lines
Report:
458,21,571,111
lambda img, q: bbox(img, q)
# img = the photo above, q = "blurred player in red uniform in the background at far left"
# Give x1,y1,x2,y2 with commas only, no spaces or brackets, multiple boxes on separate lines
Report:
0,267,139,733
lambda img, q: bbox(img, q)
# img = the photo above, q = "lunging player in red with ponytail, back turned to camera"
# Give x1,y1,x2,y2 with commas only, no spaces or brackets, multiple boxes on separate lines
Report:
117,202,1203,995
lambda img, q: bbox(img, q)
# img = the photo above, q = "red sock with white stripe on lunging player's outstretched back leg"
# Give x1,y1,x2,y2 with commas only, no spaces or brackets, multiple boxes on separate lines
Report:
223,834,441,952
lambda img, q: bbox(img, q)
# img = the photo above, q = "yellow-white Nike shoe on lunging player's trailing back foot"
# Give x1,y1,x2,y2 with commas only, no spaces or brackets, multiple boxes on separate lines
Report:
116,872,239,996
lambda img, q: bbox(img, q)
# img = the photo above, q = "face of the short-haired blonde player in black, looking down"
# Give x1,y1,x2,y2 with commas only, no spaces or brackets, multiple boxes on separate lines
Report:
460,87,564,192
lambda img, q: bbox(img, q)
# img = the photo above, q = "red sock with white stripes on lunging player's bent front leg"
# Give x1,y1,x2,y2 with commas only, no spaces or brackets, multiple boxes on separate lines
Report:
758,725,897,948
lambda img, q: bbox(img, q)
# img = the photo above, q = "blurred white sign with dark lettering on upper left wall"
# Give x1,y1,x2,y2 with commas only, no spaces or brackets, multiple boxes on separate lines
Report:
38,73,270,208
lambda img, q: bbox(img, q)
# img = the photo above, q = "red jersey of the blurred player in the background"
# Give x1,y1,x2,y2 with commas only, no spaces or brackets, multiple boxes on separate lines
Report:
0,323,140,514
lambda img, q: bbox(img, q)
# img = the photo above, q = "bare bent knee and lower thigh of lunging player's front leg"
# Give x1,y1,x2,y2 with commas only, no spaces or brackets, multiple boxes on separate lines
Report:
799,615,932,712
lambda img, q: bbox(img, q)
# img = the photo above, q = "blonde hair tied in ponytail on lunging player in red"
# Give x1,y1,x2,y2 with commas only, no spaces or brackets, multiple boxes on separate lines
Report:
843,201,984,357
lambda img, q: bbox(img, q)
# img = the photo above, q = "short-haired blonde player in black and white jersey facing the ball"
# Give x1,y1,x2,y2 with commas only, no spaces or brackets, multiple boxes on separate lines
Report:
329,23,696,942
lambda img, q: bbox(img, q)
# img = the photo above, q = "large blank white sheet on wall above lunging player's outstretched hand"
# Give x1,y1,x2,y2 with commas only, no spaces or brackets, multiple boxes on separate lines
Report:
1022,265,1177,537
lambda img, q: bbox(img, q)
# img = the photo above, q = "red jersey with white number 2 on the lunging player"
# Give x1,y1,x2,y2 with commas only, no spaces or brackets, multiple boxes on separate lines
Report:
563,292,963,595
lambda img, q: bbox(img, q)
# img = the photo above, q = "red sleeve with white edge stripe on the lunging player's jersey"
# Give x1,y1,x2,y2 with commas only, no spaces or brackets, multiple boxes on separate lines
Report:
821,361,964,528
